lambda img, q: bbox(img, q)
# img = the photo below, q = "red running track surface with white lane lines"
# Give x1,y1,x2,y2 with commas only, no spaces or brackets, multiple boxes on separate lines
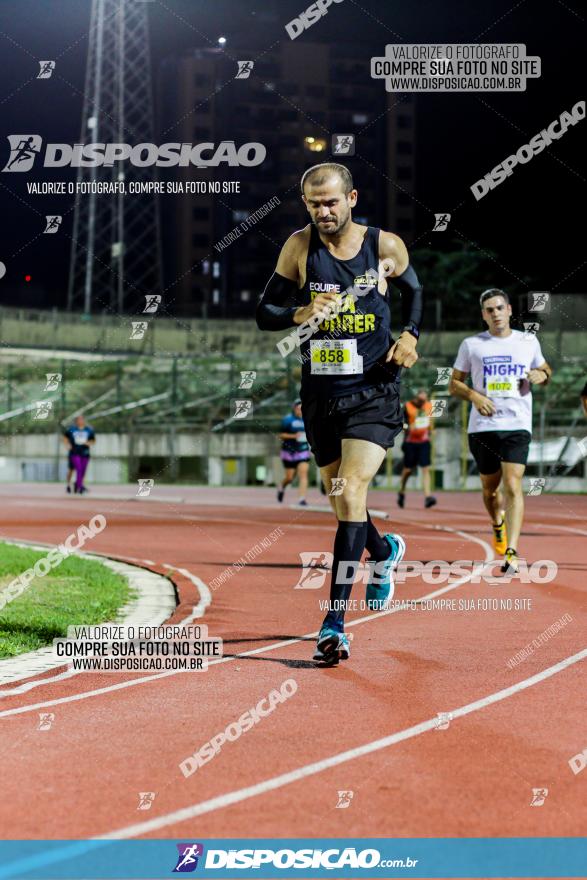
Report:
0,486,587,856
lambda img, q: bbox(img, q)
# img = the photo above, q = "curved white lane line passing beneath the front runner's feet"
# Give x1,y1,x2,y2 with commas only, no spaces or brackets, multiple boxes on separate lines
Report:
0,526,493,718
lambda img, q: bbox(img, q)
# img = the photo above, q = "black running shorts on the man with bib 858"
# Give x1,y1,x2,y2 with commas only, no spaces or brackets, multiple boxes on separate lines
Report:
302,383,403,467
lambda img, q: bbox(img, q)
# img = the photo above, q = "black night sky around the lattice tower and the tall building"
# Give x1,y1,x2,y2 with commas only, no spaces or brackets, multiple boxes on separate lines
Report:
0,0,587,306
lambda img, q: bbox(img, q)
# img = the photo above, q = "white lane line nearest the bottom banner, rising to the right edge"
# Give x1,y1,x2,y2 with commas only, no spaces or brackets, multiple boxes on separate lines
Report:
99,648,587,840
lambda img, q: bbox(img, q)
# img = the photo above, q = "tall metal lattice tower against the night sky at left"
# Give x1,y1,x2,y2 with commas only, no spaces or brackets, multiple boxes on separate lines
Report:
67,0,162,314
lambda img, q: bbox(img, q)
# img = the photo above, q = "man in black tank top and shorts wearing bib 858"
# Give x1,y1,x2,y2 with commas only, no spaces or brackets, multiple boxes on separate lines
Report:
257,163,422,662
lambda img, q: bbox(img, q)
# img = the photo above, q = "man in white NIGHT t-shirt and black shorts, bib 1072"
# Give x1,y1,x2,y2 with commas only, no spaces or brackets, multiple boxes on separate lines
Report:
450,288,552,573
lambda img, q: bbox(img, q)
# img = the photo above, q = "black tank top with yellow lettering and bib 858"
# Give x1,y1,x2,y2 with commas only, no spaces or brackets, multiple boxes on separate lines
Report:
299,224,398,397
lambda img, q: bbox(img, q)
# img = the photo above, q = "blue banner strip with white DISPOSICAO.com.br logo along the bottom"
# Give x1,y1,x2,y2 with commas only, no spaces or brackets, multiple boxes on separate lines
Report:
0,837,587,880
